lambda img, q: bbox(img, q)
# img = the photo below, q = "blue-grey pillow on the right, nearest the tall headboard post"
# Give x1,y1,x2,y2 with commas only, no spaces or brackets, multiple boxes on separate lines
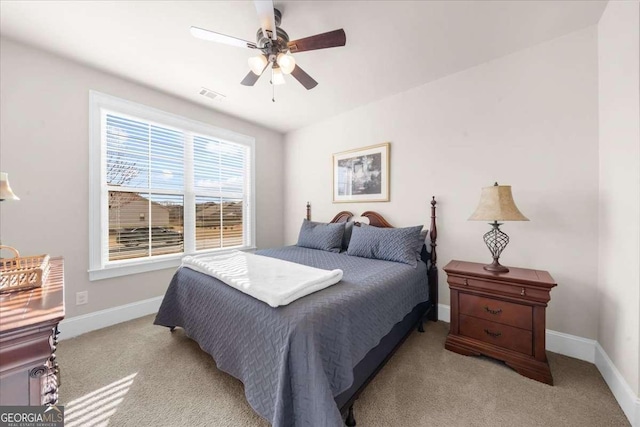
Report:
347,225,422,267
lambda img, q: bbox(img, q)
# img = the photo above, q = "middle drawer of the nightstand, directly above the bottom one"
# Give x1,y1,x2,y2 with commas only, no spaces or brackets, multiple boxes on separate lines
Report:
459,292,533,331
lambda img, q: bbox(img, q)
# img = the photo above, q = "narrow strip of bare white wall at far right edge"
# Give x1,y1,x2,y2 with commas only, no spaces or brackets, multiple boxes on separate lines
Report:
598,1,640,398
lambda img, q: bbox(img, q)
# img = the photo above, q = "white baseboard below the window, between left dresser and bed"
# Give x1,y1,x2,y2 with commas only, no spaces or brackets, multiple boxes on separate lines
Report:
59,297,163,340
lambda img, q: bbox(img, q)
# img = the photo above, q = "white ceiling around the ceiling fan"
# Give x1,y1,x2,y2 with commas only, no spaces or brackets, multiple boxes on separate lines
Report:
0,0,606,132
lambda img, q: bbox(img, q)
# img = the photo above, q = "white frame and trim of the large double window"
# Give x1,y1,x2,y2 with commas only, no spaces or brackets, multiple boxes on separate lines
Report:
88,90,256,281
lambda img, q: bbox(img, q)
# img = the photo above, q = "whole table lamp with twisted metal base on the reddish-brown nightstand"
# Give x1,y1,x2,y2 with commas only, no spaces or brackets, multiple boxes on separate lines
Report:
469,182,529,273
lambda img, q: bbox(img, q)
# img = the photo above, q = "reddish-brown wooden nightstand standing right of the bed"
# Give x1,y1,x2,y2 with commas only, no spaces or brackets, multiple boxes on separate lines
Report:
444,261,556,385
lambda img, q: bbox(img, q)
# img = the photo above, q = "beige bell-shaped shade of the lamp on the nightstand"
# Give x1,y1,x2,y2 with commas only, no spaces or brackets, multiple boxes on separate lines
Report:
469,182,529,221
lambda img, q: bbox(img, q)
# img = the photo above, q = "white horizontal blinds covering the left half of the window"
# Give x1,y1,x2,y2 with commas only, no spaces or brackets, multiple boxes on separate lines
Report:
105,114,185,261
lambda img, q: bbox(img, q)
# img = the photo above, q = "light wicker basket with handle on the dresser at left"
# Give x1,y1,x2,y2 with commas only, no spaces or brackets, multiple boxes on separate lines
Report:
0,246,49,292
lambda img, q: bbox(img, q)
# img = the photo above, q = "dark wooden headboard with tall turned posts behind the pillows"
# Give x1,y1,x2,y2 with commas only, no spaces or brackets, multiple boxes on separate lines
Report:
307,196,438,321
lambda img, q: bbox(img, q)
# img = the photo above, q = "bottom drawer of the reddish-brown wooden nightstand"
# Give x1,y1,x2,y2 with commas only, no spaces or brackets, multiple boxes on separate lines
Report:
460,314,533,355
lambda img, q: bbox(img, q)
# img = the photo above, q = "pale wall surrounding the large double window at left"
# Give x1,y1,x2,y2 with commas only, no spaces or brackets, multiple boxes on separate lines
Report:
0,39,283,317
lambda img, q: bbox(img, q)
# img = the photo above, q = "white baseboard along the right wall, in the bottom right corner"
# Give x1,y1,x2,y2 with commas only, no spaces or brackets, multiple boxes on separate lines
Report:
595,343,640,427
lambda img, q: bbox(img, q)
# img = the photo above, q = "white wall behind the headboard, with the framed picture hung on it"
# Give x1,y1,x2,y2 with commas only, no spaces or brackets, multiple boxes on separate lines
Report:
285,27,599,338
